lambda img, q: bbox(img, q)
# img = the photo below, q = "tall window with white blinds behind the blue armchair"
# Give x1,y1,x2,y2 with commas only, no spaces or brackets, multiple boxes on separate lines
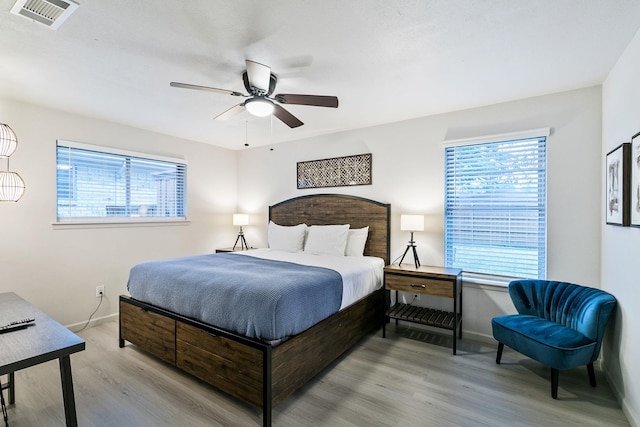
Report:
445,129,548,279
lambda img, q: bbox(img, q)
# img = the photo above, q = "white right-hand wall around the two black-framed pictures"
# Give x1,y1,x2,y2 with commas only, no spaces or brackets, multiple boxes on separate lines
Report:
600,25,640,426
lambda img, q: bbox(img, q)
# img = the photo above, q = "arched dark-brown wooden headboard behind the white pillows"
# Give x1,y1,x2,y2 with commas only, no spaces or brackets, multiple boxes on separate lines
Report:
269,194,391,264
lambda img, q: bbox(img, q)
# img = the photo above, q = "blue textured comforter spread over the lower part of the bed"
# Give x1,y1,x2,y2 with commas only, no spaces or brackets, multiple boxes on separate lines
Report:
127,253,342,341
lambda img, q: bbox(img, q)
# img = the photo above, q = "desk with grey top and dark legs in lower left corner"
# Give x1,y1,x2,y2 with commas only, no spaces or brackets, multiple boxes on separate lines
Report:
0,292,85,426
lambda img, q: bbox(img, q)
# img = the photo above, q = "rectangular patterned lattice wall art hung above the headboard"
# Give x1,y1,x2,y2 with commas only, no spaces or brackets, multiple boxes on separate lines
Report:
297,153,371,189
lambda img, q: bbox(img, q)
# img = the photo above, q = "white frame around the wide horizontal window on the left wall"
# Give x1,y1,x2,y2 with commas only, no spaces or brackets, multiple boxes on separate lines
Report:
53,140,189,228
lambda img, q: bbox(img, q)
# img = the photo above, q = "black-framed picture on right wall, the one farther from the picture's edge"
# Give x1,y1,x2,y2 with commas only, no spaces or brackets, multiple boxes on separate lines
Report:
605,141,640,226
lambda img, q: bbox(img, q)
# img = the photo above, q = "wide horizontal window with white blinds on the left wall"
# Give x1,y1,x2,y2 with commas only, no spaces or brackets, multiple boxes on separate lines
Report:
56,141,187,222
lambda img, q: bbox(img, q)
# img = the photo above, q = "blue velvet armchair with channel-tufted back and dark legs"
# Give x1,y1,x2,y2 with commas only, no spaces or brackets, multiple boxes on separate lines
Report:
491,280,616,399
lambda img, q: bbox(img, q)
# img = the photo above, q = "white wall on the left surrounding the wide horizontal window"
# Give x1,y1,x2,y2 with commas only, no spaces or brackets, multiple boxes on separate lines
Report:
0,100,236,325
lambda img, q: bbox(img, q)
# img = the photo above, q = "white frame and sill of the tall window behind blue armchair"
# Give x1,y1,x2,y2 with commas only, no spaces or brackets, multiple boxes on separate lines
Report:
443,128,550,285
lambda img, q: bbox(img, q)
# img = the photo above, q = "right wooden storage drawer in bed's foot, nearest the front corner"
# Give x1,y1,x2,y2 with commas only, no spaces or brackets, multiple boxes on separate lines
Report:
176,321,263,408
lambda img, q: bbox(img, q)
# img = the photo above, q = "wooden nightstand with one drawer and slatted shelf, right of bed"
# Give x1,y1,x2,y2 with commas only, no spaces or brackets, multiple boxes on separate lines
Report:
382,264,462,354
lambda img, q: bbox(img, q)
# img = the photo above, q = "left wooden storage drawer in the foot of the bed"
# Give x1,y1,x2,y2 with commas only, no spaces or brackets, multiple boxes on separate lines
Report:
120,301,176,365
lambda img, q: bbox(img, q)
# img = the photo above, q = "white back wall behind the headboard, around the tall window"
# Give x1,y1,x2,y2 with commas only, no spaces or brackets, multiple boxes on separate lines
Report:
238,86,602,340
